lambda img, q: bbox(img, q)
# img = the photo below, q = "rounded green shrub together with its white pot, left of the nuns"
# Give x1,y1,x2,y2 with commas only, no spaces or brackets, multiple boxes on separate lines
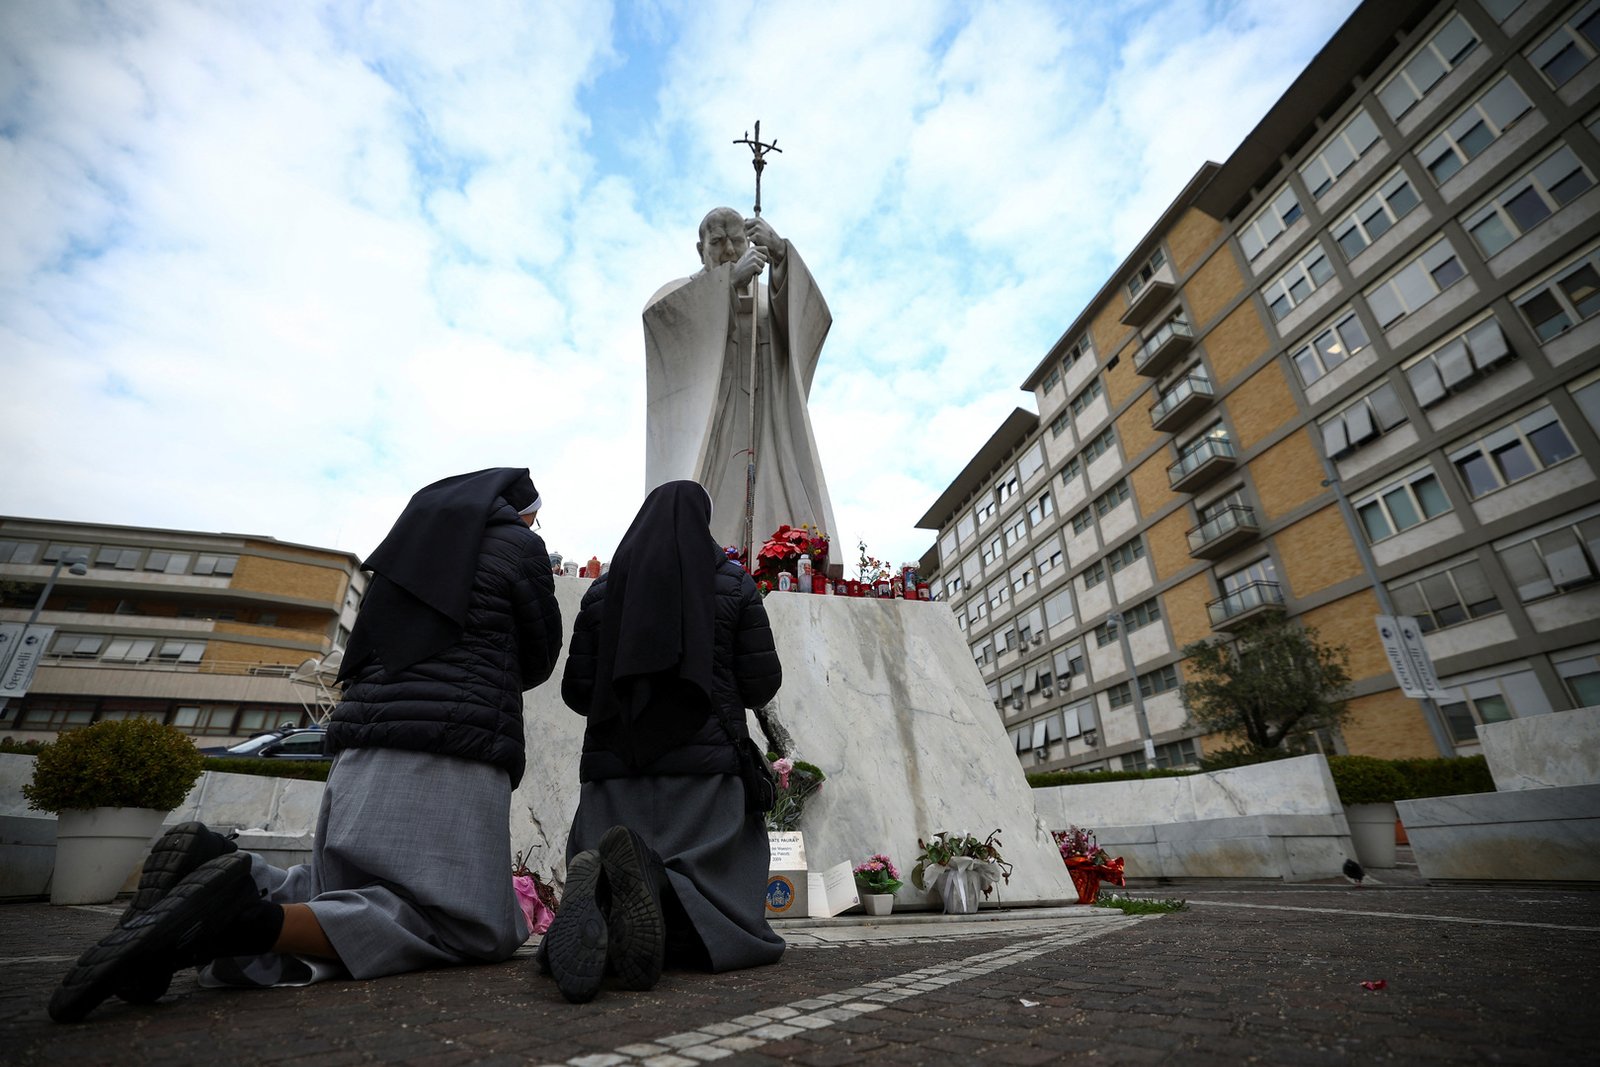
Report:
22,718,205,904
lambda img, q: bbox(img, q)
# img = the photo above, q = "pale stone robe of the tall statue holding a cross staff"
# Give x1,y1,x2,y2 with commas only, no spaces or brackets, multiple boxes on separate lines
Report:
645,242,840,563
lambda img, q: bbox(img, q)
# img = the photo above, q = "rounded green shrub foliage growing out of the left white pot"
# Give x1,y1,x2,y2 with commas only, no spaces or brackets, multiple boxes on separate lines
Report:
22,718,205,814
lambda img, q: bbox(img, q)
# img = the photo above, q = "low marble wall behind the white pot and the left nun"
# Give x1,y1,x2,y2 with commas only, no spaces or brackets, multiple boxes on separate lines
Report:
0,752,322,899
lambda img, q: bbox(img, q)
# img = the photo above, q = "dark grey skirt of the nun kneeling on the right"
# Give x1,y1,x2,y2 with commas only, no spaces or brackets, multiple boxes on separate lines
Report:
566,774,784,971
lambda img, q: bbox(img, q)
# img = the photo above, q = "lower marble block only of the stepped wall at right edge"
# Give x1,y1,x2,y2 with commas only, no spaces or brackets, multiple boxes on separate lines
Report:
1395,785,1600,881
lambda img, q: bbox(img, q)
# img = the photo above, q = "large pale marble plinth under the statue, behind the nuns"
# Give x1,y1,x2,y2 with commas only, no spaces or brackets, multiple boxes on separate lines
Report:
512,581,1075,907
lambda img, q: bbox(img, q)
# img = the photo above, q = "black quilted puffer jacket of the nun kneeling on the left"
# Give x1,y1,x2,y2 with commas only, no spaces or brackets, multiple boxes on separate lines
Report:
326,504,562,789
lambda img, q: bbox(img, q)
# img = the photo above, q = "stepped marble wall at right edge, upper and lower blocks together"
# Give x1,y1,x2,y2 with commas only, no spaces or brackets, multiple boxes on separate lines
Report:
1395,707,1600,881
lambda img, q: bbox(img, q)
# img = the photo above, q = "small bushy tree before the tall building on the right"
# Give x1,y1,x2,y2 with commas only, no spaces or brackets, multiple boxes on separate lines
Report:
1181,613,1350,749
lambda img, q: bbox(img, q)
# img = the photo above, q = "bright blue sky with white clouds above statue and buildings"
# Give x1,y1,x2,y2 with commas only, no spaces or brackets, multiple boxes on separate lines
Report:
0,0,1355,572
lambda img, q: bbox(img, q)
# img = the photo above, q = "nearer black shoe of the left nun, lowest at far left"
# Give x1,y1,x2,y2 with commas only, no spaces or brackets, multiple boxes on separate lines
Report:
50,853,256,1022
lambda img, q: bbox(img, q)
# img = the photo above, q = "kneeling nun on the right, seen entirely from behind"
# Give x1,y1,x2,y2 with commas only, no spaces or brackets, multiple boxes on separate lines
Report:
539,482,784,1001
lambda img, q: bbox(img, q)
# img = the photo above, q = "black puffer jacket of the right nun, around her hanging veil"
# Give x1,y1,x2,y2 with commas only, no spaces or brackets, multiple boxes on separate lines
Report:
562,560,784,782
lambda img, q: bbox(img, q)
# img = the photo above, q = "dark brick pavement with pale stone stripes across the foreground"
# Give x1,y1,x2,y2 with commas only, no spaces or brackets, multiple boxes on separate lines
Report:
0,885,1600,1067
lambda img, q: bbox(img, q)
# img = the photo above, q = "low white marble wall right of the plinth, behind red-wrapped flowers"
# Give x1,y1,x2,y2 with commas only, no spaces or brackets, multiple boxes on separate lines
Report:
1034,755,1354,881
